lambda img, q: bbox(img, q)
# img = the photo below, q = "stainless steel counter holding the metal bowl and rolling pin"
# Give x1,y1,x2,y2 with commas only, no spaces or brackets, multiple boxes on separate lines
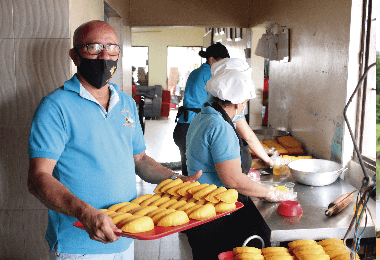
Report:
251,175,376,246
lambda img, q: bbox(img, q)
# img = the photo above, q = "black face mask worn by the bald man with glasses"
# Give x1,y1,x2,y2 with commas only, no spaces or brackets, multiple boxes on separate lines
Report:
78,57,117,89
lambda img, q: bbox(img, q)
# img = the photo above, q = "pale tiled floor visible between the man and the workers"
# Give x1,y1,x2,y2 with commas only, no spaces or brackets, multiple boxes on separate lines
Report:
135,110,193,260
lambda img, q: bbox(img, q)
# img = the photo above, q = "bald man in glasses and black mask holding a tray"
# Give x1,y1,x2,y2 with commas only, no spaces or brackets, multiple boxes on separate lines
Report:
28,21,201,259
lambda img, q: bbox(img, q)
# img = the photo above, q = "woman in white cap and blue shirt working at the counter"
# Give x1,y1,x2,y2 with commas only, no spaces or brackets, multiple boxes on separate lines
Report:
186,59,286,260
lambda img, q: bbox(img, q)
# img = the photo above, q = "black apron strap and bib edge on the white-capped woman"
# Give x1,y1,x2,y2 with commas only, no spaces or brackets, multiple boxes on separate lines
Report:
204,102,252,174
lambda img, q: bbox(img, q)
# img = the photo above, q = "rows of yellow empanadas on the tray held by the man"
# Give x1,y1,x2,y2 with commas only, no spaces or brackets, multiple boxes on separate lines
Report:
101,179,238,233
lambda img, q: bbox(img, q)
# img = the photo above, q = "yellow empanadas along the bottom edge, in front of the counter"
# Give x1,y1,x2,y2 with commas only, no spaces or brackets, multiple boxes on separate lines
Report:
227,238,359,260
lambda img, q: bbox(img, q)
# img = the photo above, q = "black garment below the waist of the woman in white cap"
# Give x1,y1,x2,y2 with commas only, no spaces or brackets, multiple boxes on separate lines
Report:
184,195,270,260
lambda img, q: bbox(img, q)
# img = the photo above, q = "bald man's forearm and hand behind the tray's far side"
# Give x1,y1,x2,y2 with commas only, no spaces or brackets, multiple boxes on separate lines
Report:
133,152,202,184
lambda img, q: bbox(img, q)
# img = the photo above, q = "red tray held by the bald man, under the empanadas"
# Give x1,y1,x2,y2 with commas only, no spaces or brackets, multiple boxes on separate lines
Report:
73,202,244,240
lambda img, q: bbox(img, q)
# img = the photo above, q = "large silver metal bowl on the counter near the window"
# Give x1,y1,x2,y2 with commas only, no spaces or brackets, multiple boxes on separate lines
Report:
288,159,347,186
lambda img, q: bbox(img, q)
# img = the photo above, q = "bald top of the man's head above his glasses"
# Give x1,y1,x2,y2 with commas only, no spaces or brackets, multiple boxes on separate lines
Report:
73,20,118,46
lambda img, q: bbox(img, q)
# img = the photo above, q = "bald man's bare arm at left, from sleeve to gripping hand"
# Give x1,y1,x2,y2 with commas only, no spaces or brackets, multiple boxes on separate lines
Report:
28,158,118,243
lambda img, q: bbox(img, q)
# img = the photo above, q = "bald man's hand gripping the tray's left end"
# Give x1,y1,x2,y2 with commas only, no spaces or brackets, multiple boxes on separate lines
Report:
79,208,119,244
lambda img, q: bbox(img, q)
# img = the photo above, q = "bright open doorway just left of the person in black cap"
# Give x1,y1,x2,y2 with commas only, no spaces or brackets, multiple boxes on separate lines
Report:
166,46,202,105
